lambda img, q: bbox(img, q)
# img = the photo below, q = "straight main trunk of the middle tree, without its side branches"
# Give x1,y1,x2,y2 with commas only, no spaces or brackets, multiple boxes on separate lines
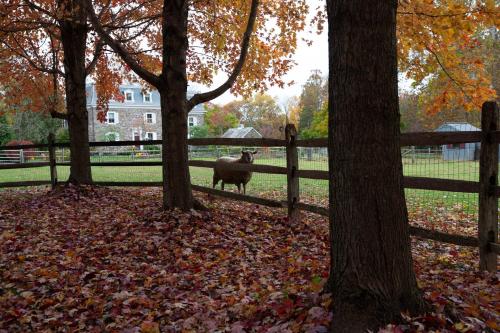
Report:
160,1,193,210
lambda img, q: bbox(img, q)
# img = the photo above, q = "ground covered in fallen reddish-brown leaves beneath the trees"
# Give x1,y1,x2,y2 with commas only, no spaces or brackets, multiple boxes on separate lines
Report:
0,187,500,333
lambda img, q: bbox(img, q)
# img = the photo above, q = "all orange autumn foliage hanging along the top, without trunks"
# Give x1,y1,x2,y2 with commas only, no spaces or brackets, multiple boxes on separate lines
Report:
0,0,498,118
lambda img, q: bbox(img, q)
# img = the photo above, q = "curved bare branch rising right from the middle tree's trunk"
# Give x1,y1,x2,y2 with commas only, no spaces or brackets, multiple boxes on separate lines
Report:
187,0,259,111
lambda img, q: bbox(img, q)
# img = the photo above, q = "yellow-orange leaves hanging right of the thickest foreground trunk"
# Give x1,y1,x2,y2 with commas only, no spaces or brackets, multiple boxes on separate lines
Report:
397,0,498,113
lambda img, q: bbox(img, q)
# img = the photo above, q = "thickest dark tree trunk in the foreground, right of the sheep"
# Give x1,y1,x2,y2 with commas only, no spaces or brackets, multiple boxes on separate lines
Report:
327,0,423,332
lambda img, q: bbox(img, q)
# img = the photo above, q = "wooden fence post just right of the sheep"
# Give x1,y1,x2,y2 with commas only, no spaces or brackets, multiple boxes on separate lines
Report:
285,124,300,222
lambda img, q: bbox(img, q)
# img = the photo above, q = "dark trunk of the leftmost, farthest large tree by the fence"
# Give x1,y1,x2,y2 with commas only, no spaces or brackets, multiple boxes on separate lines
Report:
60,8,92,184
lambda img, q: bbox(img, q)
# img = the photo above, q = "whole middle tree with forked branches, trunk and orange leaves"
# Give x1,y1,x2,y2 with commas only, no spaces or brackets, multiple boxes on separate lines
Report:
87,0,307,209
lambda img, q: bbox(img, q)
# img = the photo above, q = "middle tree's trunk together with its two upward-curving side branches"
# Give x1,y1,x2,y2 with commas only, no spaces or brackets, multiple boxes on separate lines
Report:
85,0,259,210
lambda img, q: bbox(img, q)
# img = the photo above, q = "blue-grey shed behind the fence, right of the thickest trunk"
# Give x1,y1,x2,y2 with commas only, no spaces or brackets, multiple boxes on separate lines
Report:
436,123,481,161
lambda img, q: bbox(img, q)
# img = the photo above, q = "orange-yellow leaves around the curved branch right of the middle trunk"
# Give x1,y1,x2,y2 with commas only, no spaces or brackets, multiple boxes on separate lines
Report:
188,0,309,97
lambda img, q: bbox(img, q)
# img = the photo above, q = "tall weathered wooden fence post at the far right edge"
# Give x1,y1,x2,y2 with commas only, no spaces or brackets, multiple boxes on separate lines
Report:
478,102,498,272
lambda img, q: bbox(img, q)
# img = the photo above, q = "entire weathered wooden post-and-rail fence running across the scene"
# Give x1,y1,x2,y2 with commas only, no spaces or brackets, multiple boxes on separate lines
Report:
0,102,500,271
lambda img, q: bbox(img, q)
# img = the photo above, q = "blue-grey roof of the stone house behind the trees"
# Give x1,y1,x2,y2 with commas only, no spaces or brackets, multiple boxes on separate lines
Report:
85,83,206,114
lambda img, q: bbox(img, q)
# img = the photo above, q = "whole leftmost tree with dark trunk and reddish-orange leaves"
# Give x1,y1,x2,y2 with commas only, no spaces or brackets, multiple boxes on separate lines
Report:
0,0,109,184
